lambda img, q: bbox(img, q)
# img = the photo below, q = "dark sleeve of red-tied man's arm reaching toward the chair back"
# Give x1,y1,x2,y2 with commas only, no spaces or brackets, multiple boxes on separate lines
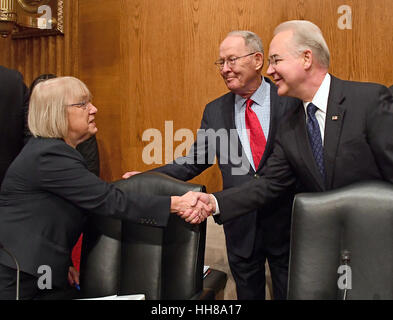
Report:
151,107,216,181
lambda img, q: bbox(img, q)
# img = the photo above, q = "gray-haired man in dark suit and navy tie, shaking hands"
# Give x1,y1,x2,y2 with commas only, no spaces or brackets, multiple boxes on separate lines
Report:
192,21,393,229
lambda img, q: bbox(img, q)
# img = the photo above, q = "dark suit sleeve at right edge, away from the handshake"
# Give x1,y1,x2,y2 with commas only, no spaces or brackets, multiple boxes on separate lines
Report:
367,86,393,183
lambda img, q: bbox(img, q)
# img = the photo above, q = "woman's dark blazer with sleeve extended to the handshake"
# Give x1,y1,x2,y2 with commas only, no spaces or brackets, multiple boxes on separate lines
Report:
0,138,170,286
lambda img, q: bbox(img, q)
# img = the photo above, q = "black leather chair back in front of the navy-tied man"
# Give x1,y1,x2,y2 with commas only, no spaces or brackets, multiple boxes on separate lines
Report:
288,181,393,300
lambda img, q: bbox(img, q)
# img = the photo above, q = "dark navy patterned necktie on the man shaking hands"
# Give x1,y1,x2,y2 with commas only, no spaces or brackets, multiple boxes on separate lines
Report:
307,103,325,179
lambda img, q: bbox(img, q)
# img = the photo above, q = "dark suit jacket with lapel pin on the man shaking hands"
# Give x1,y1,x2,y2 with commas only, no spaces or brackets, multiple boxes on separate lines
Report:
215,76,393,222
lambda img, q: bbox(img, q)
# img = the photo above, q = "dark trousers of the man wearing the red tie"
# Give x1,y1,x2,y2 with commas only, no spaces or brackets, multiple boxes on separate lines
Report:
227,225,289,300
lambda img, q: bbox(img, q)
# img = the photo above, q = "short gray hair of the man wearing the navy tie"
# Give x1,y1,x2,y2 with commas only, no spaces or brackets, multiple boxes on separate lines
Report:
274,20,330,68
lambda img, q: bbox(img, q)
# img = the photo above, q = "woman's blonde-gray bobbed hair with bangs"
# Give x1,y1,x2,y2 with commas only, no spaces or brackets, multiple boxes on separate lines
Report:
27,77,91,138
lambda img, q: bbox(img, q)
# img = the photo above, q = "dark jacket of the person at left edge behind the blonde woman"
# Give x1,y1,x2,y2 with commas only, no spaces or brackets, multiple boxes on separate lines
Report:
0,66,29,186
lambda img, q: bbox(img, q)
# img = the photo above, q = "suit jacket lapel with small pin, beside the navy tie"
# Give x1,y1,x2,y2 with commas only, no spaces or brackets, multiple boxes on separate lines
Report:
324,75,345,189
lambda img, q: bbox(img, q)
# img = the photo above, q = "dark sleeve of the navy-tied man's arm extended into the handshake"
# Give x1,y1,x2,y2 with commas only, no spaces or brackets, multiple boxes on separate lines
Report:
214,124,296,224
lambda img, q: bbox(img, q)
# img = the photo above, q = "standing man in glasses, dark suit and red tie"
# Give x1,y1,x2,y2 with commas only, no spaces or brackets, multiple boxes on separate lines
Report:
125,31,293,300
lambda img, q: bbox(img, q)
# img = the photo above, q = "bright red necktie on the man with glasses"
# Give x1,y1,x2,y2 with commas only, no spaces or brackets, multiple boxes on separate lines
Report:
246,99,266,171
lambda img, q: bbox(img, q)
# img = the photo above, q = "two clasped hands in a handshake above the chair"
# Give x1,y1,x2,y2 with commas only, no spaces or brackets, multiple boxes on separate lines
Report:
171,191,215,224
